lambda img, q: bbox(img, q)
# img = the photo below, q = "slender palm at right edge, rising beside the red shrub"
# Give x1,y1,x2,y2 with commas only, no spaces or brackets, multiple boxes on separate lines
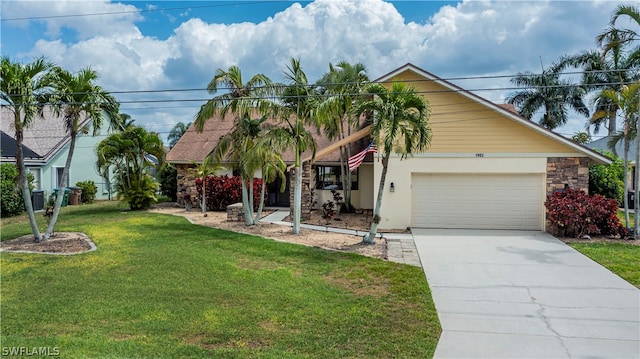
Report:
600,82,640,237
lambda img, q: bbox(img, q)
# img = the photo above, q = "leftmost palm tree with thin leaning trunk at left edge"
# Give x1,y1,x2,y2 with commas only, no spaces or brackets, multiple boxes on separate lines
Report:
0,57,53,242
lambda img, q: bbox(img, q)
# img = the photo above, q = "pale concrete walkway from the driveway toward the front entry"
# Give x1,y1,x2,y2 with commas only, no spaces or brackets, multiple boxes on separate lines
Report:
260,209,421,267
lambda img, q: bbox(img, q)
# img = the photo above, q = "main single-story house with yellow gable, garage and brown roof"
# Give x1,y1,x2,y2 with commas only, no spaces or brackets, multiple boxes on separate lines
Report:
167,64,611,230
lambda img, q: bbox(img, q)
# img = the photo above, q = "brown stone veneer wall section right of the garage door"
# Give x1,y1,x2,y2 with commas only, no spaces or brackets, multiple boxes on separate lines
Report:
547,157,589,195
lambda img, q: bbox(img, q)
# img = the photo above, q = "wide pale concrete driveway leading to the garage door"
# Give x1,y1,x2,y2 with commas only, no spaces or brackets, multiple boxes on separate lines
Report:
412,229,640,358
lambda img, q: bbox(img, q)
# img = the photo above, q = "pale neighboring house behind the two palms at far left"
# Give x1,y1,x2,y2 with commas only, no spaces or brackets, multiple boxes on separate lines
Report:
0,106,115,207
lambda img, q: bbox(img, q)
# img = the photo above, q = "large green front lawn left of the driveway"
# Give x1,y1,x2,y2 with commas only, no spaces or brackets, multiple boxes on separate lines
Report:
0,203,440,358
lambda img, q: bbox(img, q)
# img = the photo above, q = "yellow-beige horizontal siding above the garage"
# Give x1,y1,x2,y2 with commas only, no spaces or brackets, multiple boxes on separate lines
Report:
388,71,576,153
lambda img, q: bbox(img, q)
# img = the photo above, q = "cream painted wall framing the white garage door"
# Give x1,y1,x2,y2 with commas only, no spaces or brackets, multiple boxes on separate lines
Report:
372,157,547,230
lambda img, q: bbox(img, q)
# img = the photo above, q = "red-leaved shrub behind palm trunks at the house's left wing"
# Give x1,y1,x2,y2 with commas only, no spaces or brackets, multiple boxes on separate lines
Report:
204,175,267,211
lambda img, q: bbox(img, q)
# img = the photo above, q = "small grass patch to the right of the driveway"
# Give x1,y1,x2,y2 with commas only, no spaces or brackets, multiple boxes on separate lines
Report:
569,242,640,288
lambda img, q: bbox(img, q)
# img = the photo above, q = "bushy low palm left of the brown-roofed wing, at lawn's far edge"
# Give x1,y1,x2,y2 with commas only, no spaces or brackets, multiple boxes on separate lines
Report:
96,126,164,210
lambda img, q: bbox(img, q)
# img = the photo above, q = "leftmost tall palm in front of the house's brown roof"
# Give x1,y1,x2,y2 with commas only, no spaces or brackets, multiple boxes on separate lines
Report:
194,66,273,225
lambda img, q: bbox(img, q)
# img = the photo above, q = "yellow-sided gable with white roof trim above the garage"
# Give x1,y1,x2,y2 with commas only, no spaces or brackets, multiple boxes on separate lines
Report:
376,64,611,163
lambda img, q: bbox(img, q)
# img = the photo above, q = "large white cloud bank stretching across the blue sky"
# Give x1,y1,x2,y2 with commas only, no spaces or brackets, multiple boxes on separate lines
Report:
3,0,617,141
